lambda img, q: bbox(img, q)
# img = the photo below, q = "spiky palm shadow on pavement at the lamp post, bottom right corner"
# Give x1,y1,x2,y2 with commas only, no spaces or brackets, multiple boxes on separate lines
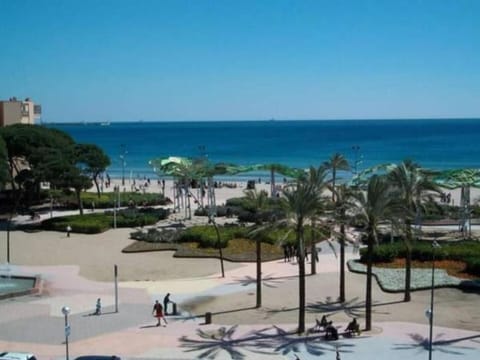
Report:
393,333,480,356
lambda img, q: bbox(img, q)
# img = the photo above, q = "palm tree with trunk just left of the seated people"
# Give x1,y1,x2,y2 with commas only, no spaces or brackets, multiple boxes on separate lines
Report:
281,167,323,334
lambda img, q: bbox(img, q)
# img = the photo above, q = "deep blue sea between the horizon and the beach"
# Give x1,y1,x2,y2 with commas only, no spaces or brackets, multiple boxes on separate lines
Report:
44,119,480,181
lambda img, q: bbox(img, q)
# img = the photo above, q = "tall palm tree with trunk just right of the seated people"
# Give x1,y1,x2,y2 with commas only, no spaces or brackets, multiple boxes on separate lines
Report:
354,175,396,330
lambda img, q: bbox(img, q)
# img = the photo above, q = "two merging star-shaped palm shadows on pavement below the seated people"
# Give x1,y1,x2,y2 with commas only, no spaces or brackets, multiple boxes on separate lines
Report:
180,325,354,360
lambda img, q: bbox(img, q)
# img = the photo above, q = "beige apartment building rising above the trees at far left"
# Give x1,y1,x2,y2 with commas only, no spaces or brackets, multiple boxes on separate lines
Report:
0,97,42,126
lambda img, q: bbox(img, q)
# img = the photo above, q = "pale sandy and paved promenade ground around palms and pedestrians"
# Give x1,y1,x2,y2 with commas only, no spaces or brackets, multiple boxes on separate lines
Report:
0,184,480,360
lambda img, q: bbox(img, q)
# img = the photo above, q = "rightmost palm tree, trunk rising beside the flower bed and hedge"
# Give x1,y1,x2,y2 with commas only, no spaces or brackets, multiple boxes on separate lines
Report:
388,160,440,302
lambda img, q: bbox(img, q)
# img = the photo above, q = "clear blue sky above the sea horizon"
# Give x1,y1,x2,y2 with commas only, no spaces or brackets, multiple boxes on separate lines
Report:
0,0,480,122
